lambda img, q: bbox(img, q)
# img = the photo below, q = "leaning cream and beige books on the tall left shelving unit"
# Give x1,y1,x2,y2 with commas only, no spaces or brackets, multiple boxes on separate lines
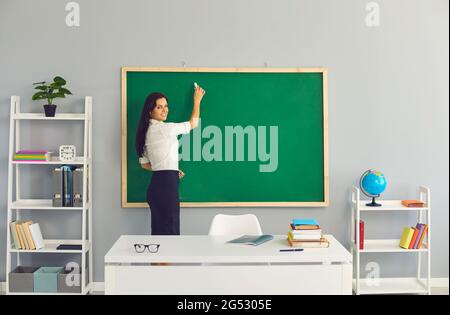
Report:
9,221,45,250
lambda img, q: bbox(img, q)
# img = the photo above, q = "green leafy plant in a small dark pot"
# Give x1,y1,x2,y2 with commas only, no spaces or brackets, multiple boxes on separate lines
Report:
32,76,72,117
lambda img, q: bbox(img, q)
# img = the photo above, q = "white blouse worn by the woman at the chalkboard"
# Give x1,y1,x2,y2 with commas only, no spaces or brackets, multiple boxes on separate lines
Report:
139,119,191,171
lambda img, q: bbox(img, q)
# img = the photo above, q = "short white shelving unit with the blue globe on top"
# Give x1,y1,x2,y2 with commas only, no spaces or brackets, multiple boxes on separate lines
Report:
350,187,431,295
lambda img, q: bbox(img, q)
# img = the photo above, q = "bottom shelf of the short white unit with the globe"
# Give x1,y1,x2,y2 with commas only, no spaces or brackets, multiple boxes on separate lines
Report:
353,278,428,294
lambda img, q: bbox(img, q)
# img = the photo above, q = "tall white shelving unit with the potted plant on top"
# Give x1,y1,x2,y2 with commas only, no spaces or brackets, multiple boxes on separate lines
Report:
6,96,93,295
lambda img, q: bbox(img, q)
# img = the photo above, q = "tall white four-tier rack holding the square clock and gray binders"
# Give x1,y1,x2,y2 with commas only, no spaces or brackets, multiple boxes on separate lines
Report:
6,96,93,295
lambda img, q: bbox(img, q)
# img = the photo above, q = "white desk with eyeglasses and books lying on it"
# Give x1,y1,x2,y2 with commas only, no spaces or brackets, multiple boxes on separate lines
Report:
105,235,353,295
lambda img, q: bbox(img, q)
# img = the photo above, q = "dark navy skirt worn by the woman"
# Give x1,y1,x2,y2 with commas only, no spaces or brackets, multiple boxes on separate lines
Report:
147,171,180,235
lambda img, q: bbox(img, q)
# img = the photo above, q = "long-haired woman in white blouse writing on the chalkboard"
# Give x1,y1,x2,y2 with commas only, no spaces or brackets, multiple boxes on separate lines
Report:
136,84,205,235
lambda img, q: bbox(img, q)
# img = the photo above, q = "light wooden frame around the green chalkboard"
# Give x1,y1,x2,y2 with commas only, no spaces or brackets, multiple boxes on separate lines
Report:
121,67,329,208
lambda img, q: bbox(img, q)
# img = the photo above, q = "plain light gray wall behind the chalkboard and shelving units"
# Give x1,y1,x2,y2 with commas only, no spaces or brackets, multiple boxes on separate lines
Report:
0,0,449,281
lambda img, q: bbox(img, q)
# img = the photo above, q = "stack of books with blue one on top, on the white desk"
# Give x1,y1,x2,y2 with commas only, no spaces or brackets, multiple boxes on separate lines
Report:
288,219,330,248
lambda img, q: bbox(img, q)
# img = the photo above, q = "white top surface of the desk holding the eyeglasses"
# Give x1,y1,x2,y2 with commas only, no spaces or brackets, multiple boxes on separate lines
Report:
105,235,352,264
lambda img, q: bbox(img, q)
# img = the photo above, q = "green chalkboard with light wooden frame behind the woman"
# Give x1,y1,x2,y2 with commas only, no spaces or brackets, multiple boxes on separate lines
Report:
122,67,328,207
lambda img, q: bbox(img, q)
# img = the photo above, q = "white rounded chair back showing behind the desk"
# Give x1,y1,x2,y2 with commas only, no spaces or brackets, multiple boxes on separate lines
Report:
208,214,262,235
